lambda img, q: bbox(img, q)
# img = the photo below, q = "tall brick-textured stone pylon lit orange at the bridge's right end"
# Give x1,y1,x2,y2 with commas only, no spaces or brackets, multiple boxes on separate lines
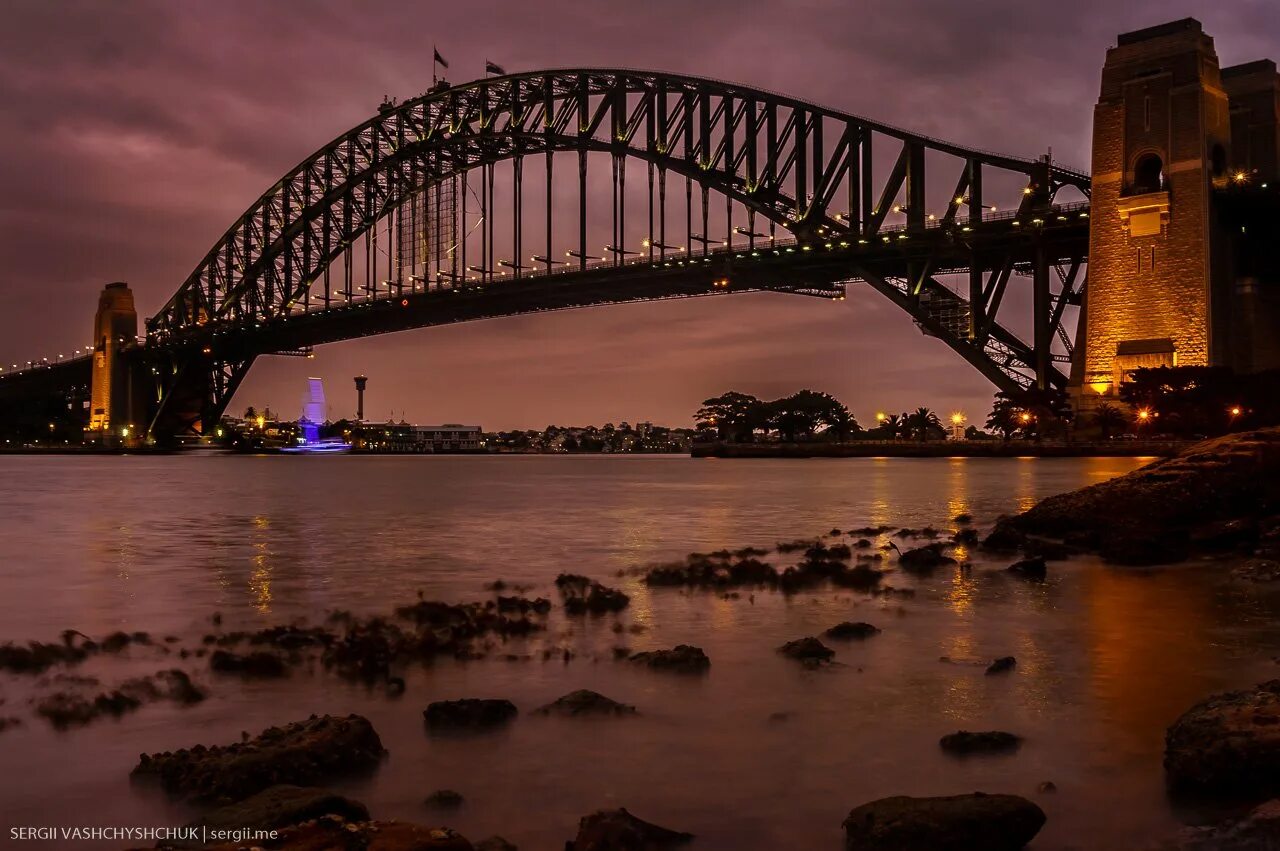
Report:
1073,18,1231,408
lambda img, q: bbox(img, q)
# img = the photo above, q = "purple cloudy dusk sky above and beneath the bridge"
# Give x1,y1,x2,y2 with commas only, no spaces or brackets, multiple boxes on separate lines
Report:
0,0,1280,429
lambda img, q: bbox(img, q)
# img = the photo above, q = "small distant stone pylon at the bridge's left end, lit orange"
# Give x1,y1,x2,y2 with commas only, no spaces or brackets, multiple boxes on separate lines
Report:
88,282,138,443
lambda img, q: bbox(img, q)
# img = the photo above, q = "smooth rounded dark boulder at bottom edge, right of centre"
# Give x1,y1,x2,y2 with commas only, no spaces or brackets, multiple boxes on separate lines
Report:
845,792,1044,851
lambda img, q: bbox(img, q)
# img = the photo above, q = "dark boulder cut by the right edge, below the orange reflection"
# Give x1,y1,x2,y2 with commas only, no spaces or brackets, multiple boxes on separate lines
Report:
1165,680,1280,800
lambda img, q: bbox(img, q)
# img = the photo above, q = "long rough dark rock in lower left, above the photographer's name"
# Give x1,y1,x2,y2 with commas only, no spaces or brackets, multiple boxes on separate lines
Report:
133,715,387,801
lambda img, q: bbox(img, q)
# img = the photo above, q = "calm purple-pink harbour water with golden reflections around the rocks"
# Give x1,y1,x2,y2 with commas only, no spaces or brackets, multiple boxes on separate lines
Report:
0,457,1280,851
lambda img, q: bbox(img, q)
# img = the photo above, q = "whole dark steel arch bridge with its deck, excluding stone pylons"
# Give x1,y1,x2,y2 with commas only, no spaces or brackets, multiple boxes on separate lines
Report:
2,69,1089,439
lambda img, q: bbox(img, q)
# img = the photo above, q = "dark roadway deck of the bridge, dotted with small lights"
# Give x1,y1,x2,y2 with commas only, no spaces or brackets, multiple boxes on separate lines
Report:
147,203,1088,358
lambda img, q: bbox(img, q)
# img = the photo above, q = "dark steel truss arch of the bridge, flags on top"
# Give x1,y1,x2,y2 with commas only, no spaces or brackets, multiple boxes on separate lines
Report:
147,69,1089,431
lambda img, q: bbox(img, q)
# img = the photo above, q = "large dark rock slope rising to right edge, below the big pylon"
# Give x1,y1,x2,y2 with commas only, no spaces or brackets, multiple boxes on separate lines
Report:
992,427,1280,564
